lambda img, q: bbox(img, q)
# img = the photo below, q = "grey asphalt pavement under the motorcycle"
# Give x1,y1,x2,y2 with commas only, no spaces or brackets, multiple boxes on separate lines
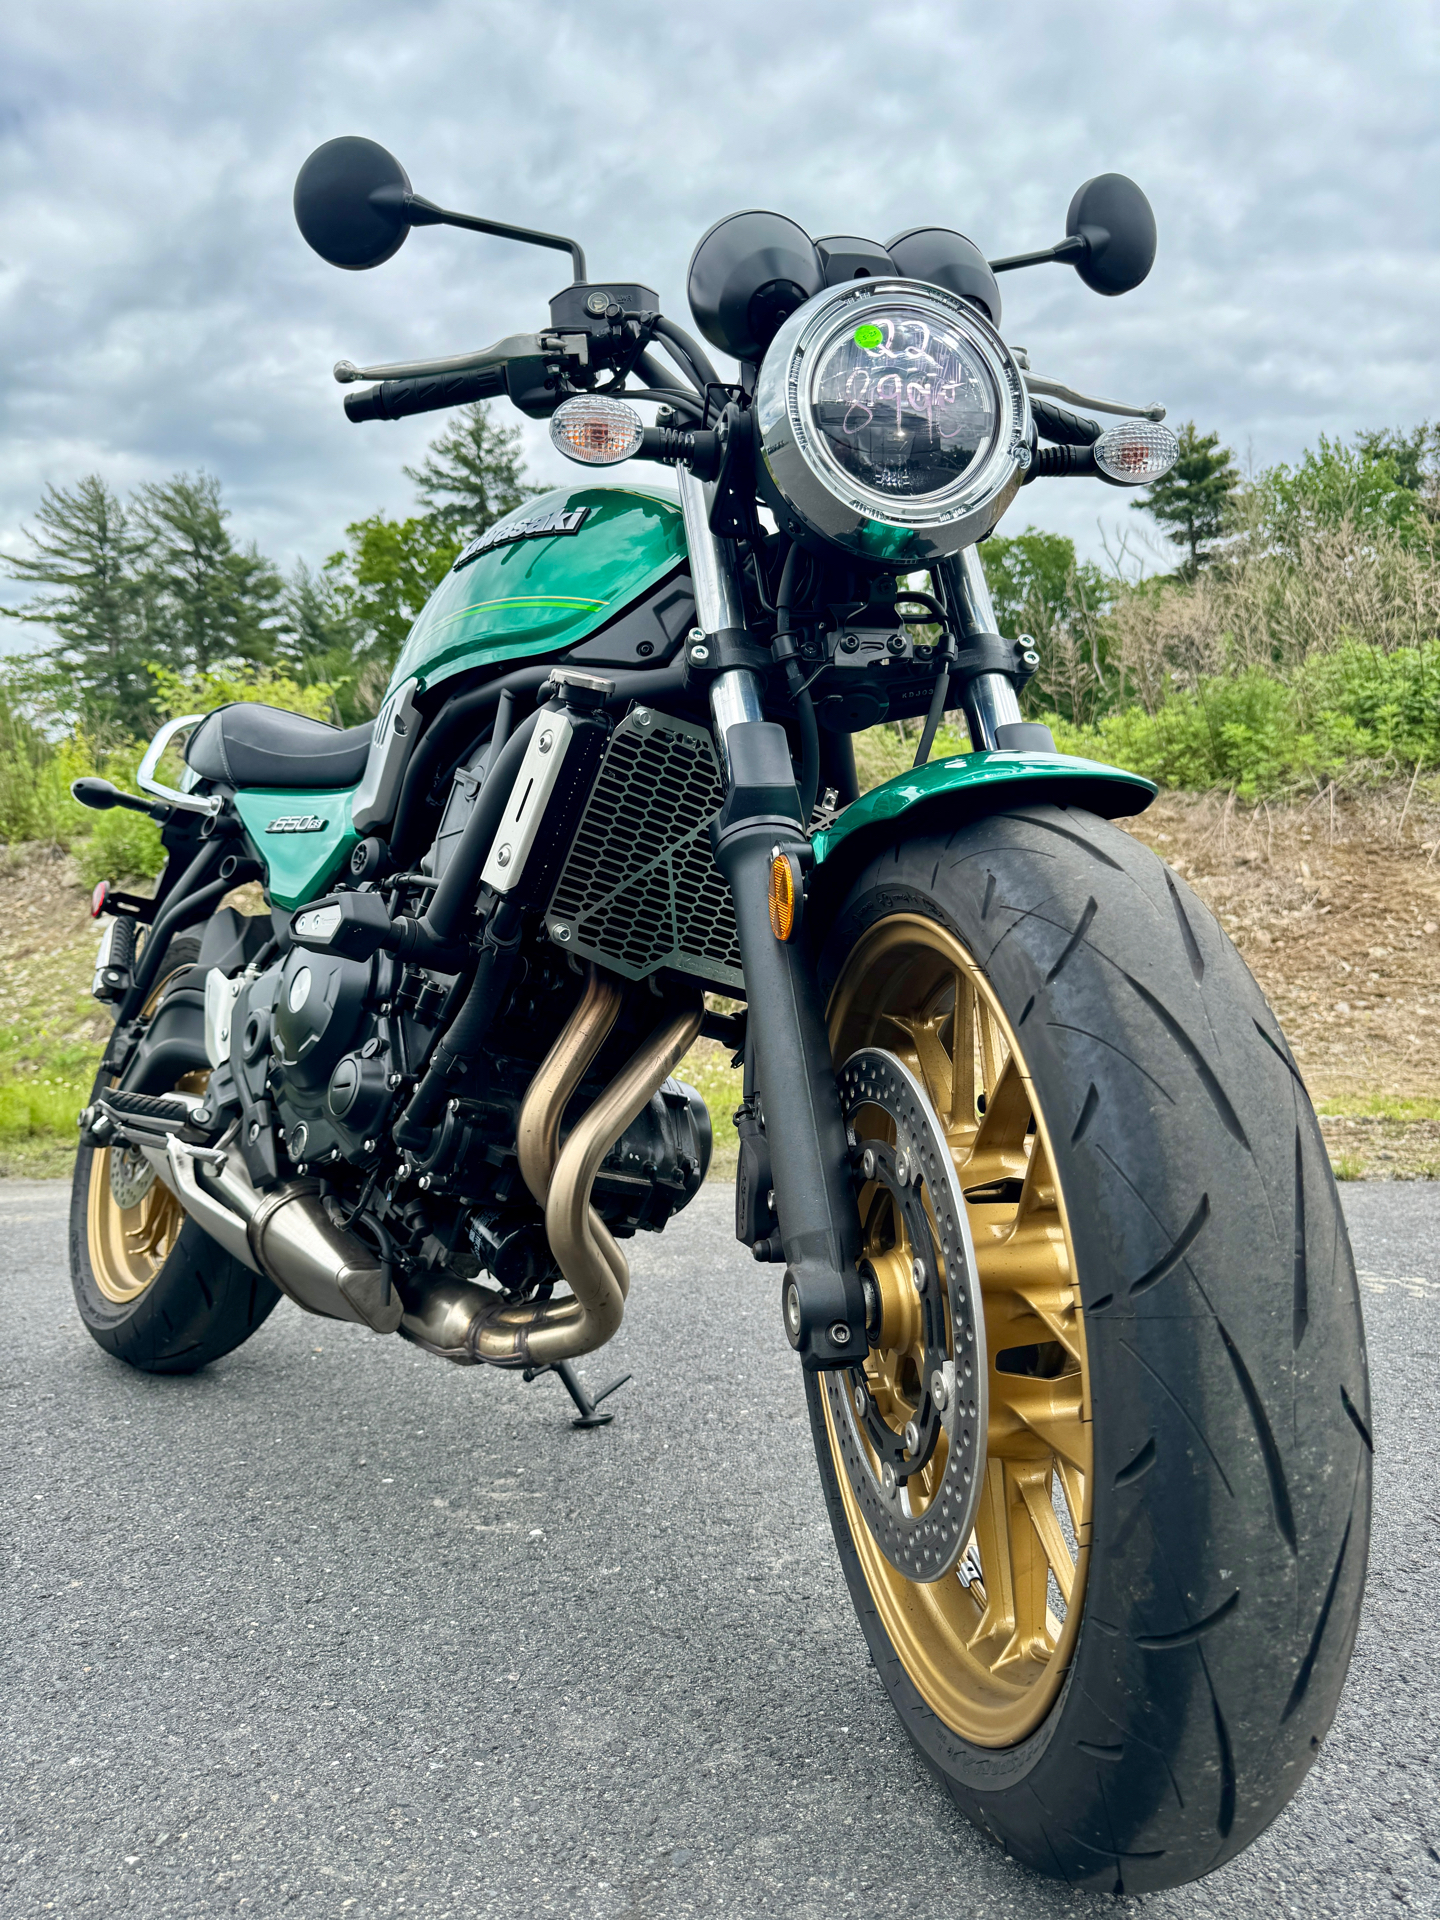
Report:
0,1181,1437,1917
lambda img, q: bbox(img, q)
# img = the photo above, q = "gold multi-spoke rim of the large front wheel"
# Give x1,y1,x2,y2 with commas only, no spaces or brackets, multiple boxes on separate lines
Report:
826,914,1091,1748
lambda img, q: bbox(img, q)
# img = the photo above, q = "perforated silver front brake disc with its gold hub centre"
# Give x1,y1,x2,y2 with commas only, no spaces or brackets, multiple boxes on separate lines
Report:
824,1047,986,1581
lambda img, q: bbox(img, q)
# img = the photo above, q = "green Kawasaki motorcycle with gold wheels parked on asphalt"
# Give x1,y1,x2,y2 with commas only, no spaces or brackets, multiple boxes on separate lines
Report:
71,138,1372,1894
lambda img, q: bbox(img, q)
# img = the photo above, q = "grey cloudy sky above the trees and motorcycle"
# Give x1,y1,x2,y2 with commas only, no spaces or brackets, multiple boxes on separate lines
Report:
0,0,1437,614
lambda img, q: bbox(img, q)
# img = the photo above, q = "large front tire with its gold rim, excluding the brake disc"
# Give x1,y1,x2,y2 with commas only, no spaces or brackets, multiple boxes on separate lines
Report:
807,805,1372,1894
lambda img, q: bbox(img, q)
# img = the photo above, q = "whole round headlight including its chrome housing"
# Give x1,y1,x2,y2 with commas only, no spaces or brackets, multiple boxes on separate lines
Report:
755,279,1032,561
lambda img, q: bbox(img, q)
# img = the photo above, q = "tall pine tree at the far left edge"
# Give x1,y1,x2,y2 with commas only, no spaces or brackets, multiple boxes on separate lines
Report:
0,474,156,734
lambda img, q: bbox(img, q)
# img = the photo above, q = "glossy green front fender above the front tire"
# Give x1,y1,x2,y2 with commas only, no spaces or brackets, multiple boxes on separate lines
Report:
811,753,1157,880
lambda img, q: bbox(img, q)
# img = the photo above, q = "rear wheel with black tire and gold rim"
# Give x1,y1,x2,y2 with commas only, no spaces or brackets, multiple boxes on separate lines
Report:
69,937,281,1374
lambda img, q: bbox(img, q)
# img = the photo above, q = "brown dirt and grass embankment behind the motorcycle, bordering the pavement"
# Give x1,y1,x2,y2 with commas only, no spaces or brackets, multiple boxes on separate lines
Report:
0,788,1441,1179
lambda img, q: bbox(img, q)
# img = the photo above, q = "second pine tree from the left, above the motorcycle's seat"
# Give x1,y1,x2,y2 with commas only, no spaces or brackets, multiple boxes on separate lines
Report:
138,473,284,674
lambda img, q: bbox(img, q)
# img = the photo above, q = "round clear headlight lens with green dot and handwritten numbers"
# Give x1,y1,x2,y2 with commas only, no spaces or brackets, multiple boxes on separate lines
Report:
811,304,1001,501
